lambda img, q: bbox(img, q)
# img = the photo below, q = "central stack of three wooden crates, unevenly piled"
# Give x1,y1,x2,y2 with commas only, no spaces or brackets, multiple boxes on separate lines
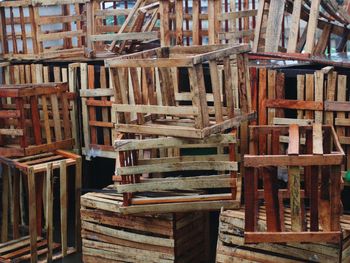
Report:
82,41,255,262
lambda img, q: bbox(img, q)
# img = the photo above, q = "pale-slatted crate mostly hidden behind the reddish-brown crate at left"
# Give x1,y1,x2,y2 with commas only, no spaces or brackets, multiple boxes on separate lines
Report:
0,63,81,153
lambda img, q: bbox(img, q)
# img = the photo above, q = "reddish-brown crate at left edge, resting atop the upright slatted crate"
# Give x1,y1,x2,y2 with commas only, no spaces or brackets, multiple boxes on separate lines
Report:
0,83,74,156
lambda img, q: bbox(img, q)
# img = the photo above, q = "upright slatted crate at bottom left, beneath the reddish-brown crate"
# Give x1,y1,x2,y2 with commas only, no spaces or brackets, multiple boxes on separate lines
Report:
0,150,82,262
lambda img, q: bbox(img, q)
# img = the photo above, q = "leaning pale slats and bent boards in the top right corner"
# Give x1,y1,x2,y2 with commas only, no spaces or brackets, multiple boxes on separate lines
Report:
253,0,350,54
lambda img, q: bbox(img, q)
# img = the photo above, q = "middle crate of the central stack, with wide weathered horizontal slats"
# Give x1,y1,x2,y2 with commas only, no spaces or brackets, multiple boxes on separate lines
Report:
113,131,241,214
